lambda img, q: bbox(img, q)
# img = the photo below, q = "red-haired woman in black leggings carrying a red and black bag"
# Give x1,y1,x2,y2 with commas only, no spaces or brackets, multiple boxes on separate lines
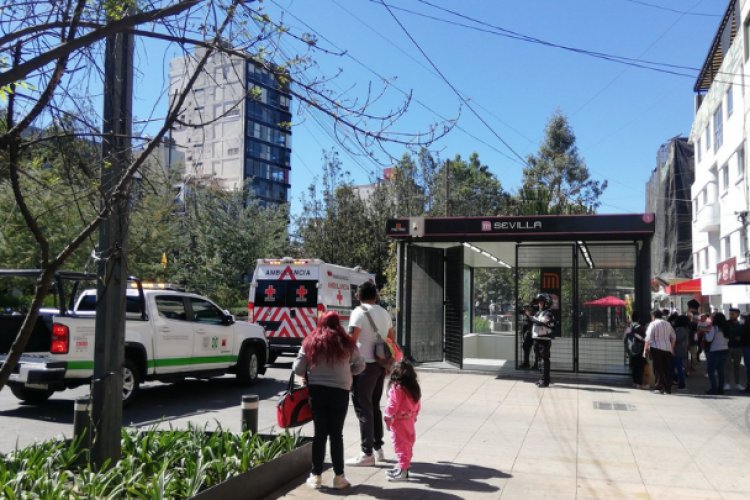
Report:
292,311,365,489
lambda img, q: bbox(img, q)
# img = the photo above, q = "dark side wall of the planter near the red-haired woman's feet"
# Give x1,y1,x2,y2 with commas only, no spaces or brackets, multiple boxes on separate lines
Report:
193,438,312,500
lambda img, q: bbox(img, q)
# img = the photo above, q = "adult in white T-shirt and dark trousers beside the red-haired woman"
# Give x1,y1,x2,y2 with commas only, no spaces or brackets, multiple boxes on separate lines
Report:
346,281,396,466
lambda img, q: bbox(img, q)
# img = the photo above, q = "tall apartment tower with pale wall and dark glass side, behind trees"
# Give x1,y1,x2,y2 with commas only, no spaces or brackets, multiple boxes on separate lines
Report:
169,49,292,203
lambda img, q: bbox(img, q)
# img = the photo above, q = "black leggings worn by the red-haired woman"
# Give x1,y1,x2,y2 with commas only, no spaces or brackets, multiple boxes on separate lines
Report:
310,385,349,476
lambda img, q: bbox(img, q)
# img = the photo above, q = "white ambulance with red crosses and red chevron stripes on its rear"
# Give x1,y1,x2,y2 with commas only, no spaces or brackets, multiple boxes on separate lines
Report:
247,257,375,363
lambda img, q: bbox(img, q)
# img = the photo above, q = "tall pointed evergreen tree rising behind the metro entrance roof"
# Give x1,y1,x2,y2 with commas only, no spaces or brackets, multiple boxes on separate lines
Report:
514,110,607,214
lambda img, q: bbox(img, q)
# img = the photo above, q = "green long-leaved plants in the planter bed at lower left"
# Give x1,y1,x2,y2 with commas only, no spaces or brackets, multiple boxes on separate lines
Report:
0,426,302,500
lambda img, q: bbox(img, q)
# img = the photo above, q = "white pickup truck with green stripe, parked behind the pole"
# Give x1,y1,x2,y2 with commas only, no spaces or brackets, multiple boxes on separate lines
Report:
0,282,268,405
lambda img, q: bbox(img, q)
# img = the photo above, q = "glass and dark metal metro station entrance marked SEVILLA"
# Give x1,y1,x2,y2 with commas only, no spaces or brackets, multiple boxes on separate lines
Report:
388,214,654,374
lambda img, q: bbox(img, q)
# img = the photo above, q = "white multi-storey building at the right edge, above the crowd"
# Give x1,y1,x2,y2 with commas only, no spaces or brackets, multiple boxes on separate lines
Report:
690,0,750,312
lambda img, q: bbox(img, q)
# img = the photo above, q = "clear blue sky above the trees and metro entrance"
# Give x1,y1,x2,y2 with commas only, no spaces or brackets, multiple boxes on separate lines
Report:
135,0,728,214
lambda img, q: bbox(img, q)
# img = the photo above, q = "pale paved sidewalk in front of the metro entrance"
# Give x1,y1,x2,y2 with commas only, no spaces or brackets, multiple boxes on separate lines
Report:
264,371,750,500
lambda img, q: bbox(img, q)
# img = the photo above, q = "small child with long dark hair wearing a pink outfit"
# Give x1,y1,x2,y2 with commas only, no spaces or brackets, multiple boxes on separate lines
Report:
384,362,422,481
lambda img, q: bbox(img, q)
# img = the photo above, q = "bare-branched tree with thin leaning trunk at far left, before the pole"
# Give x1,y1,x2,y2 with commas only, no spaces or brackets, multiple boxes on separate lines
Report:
0,0,449,394
